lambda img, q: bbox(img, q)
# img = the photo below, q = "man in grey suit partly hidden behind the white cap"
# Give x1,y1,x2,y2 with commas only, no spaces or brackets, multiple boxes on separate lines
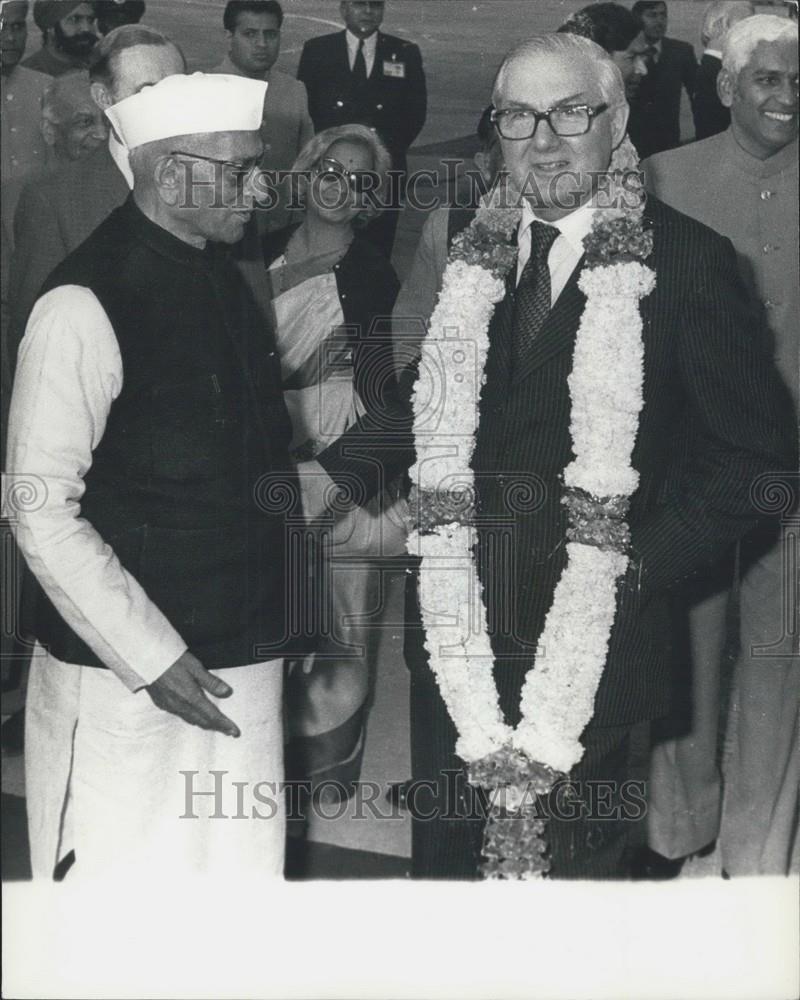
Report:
10,25,186,344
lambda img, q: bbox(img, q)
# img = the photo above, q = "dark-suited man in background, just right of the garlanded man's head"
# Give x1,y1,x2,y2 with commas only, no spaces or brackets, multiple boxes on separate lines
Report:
628,0,697,156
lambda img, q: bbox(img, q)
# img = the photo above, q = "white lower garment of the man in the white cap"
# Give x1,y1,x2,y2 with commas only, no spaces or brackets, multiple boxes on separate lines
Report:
25,654,285,878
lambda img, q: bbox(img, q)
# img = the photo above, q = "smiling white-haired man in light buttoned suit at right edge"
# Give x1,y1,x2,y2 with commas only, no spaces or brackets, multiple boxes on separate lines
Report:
644,14,800,875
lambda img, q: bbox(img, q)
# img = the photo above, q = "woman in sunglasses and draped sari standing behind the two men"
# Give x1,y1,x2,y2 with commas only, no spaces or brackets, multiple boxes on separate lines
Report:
263,125,404,812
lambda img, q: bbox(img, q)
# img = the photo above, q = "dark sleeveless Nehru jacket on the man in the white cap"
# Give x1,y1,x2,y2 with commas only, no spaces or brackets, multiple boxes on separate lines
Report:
34,197,306,669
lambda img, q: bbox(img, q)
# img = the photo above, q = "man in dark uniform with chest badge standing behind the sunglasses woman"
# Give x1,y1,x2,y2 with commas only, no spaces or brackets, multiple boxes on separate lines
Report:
297,0,428,256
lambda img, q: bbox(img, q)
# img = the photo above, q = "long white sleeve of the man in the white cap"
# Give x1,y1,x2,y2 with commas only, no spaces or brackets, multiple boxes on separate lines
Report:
4,285,187,691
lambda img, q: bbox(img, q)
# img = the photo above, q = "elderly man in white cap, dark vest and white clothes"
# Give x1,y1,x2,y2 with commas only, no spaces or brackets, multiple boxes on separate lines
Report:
6,73,312,877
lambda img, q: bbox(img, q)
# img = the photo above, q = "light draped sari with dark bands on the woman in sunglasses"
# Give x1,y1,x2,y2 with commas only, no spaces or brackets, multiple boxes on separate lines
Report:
269,248,404,798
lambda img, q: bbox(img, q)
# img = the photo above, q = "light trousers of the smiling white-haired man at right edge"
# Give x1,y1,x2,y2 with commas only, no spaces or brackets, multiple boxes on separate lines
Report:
648,535,800,875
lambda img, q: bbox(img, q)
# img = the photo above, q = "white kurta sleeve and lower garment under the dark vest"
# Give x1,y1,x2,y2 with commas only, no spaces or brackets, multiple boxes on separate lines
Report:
4,286,284,877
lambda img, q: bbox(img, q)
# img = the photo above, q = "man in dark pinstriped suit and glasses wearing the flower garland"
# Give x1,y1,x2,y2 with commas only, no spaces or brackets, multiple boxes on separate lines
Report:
406,35,797,879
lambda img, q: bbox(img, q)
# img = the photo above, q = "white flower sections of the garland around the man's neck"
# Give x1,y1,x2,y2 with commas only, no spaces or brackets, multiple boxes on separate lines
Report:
408,144,655,796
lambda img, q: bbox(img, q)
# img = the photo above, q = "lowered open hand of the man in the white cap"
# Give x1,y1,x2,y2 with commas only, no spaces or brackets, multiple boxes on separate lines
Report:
146,650,241,736
